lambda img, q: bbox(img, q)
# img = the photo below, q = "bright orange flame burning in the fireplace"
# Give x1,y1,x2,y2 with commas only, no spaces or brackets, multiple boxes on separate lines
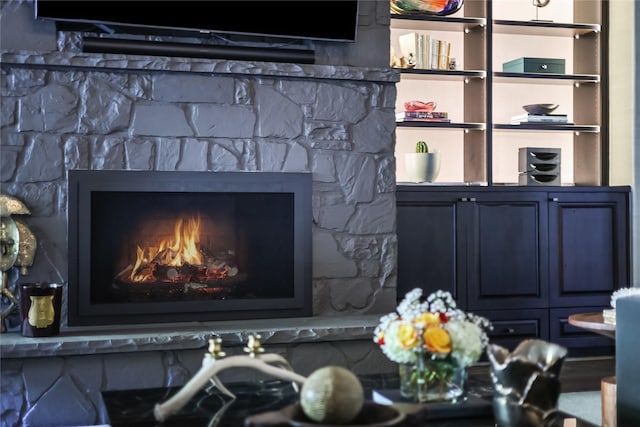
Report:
129,217,202,282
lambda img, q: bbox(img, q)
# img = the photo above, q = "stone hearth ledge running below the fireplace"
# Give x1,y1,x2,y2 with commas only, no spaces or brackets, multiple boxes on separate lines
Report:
0,314,380,359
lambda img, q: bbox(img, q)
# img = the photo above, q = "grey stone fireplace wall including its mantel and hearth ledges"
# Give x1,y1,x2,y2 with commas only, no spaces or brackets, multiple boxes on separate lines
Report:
0,0,398,426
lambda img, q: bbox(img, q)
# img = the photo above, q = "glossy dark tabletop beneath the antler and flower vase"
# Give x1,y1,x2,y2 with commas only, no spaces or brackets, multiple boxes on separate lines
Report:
102,374,595,427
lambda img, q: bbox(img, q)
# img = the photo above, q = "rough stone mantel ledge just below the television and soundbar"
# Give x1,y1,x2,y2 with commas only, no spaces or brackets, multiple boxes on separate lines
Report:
0,52,400,83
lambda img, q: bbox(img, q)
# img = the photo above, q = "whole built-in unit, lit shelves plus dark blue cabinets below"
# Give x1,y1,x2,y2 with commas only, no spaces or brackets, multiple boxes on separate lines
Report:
391,0,631,355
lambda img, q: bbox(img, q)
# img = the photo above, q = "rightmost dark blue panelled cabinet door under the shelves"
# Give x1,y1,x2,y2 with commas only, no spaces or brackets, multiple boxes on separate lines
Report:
549,191,631,307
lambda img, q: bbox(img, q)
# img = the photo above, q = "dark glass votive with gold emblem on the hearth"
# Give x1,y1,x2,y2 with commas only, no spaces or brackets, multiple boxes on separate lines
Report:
19,282,63,337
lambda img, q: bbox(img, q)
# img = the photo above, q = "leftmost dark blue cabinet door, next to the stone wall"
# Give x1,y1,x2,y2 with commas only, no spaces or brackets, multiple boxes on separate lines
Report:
397,192,466,307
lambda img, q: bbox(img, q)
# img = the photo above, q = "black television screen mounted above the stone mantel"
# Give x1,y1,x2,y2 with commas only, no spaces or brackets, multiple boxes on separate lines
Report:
35,0,358,42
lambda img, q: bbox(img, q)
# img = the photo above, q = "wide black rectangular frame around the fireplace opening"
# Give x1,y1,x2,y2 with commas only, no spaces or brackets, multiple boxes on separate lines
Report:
67,170,312,326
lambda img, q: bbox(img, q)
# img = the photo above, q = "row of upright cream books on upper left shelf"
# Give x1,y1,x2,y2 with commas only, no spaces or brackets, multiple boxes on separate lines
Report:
398,33,451,70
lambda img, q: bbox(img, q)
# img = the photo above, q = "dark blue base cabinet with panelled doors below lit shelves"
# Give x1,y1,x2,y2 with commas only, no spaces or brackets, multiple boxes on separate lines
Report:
396,185,631,348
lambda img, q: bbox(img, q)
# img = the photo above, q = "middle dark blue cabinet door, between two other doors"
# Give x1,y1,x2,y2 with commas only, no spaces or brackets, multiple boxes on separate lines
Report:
464,192,549,310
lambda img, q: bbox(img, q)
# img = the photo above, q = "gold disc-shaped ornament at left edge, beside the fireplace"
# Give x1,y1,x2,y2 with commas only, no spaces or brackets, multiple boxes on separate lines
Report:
0,194,36,332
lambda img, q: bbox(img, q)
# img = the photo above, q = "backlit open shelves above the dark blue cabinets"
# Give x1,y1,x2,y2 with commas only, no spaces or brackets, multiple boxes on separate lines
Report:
391,0,608,186
